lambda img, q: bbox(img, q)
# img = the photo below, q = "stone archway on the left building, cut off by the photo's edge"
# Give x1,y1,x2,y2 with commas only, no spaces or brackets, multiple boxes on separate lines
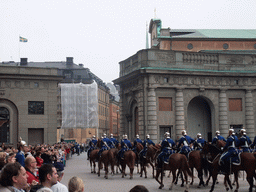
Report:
0,99,18,147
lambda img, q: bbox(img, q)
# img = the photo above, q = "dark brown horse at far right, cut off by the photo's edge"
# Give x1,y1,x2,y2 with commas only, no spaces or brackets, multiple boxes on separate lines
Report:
203,144,256,192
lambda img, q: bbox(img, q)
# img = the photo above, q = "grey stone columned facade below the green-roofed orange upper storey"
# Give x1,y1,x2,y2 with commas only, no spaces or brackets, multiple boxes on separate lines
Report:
114,49,256,142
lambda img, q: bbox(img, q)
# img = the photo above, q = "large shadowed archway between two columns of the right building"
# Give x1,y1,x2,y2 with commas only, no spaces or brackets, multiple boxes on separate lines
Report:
187,96,212,141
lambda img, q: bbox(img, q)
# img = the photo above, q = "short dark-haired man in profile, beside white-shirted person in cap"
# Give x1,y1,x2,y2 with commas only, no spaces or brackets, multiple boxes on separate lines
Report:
30,164,58,192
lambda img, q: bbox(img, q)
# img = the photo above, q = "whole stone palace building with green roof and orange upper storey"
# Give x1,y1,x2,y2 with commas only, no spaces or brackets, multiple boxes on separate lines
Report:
113,19,256,142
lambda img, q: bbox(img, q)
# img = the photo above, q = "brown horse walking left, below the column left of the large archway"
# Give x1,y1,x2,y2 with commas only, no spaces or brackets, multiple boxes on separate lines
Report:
155,153,192,192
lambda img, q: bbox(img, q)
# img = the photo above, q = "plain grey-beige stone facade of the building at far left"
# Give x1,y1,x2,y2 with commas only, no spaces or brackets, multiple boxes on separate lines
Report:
0,64,62,147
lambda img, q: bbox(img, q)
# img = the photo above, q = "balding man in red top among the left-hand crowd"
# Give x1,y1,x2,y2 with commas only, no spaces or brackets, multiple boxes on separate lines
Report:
25,156,39,185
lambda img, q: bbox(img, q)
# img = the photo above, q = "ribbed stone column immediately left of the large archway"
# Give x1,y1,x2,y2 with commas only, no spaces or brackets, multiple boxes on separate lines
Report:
175,88,185,139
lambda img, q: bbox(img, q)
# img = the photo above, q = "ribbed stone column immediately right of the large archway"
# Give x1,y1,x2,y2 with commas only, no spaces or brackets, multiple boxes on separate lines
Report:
219,89,229,137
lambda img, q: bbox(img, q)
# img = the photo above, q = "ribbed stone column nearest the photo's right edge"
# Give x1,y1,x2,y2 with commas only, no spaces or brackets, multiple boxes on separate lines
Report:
245,90,254,138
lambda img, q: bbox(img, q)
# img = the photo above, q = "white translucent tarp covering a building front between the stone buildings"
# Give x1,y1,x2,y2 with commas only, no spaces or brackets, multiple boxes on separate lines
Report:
60,82,98,129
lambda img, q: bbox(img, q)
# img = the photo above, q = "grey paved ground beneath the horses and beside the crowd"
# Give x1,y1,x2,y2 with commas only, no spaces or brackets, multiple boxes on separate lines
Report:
62,153,255,192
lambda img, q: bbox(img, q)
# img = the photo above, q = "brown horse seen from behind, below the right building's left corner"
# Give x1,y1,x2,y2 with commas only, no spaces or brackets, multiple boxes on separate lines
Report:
120,150,136,179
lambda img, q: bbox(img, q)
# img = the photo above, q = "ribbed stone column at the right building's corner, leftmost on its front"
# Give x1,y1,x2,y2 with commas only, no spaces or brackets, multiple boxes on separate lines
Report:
146,88,157,143
